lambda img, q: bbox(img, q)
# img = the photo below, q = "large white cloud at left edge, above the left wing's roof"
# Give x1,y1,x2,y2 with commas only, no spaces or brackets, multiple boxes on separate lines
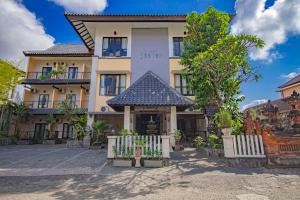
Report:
0,0,54,67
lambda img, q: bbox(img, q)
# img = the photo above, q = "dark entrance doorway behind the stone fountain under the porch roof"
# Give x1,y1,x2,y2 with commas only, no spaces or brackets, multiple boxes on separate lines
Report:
136,114,162,135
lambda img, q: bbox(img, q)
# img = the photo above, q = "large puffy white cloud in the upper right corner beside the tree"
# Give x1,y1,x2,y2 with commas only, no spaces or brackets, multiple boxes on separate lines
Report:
231,0,300,62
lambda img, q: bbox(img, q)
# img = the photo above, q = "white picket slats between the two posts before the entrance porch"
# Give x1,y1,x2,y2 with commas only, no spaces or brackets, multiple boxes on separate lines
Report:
114,135,162,157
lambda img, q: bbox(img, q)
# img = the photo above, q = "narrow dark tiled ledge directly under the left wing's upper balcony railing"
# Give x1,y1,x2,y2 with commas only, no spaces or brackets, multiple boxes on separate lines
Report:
22,79,91,85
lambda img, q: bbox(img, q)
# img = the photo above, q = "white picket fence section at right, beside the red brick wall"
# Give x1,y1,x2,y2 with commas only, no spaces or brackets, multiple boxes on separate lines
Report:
232,134,266,158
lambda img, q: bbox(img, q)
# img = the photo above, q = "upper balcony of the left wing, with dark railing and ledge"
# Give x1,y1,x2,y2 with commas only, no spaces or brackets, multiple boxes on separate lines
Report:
23,72,91,85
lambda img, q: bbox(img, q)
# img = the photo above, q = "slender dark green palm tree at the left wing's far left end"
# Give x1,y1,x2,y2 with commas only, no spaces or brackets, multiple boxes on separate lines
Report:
11,102,30,139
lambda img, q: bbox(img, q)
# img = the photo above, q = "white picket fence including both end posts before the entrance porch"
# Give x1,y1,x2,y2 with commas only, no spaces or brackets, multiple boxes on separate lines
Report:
107,135,170,158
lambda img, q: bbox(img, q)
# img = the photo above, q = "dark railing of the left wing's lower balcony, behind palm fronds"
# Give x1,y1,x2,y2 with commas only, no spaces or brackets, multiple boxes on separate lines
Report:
24,101,88,109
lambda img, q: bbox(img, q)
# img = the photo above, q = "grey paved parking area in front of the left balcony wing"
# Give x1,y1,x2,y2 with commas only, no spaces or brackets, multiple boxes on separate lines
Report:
0,145,106,176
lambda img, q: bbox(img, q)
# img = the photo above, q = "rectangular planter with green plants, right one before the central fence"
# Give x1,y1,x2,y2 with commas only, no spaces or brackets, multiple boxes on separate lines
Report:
144,148,163,168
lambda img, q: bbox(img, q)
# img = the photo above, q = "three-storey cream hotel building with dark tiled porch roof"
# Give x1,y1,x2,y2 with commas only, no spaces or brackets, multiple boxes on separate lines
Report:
19,13,211,145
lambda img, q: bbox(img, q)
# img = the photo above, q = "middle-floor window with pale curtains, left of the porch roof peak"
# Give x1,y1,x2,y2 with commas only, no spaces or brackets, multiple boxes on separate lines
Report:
100,74,126,96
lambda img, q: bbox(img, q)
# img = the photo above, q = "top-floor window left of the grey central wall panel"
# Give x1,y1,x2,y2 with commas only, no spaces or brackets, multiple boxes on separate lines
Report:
102,37,127,57
